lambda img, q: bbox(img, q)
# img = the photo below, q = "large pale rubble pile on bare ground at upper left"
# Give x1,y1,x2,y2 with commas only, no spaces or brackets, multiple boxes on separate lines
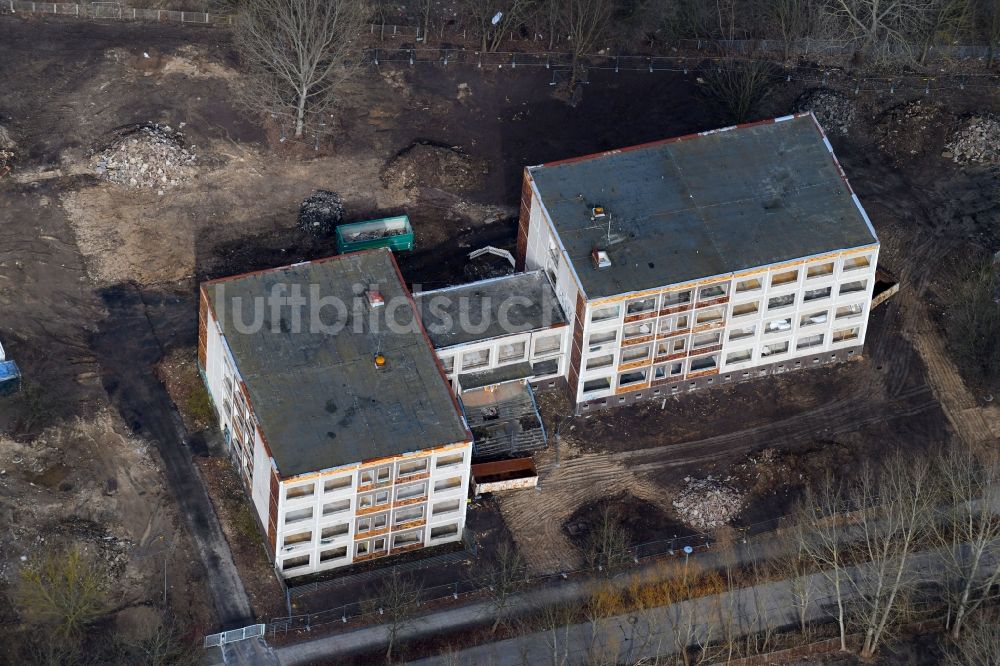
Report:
94,123,195,188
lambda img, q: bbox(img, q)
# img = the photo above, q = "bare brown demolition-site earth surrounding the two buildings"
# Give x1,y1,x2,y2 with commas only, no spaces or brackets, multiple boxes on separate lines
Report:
0,16,1000,628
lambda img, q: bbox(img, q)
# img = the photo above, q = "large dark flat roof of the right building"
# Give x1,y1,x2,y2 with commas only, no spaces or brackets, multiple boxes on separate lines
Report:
528,114,878,299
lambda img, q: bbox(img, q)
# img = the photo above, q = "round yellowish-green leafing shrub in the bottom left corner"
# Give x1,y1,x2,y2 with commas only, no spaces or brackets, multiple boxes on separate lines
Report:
17,547,109,642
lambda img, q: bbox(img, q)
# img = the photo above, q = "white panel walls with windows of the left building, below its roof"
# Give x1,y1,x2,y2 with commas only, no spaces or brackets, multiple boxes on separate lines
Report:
200,290,472,578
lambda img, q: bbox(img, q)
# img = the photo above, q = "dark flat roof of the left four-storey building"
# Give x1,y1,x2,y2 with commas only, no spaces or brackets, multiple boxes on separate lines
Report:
204,249,469,478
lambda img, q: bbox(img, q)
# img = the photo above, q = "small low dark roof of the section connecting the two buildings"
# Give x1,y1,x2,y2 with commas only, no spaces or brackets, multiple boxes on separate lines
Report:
413,271,566,349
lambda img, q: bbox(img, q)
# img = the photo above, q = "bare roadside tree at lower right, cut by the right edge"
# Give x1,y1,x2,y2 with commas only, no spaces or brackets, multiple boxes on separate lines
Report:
934,450,1000,640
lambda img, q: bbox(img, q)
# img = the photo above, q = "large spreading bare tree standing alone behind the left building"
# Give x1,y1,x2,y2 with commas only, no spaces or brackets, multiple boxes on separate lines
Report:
233,0,368,137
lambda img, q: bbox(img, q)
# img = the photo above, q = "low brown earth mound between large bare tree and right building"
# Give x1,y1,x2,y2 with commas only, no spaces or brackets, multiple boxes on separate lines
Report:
382,142,487,192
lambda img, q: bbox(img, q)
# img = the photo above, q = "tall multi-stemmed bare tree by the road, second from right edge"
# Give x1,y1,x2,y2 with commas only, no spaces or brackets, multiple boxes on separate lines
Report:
851,454,933,659
